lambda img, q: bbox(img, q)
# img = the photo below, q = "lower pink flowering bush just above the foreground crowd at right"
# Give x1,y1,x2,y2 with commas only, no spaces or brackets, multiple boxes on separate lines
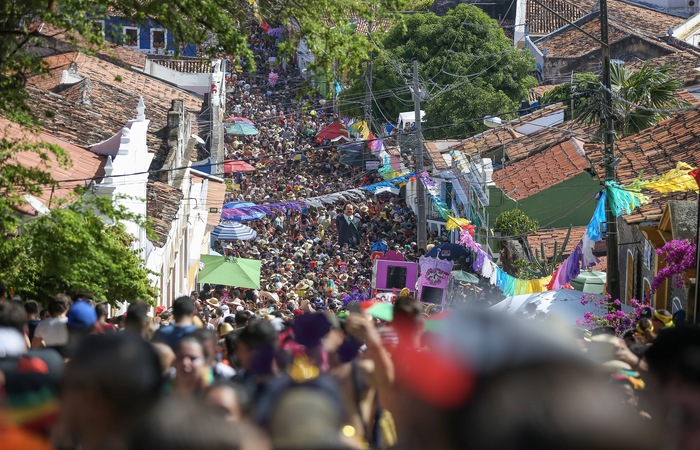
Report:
576,294,649,337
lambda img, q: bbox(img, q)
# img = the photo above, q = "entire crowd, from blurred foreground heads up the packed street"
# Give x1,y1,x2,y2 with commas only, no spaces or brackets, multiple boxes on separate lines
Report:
0,25,700,450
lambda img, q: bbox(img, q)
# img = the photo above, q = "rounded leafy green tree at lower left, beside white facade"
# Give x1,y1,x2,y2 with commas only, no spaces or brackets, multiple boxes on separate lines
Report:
0,197,157,304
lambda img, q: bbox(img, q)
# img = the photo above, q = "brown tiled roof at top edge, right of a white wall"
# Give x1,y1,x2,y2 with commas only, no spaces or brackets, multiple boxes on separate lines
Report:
525,0,596,35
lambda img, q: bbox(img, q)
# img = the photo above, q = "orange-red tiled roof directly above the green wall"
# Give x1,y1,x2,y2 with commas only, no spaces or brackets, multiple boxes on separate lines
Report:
493,139,590,200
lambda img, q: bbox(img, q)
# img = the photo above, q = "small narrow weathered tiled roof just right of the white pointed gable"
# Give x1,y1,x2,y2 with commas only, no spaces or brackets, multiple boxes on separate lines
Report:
146,181,184,247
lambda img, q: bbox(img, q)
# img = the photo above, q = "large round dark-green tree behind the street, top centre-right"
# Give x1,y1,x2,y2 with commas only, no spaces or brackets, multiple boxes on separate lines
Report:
341,4,536,139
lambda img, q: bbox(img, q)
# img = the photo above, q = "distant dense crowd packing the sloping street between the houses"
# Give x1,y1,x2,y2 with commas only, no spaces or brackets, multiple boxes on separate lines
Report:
215,29,454,310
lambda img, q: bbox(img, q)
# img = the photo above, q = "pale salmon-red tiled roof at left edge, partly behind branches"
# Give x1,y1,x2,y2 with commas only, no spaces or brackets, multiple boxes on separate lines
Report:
0,118,107,215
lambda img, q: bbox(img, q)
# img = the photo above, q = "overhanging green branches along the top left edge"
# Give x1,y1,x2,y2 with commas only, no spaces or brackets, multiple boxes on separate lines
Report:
0,0,405,123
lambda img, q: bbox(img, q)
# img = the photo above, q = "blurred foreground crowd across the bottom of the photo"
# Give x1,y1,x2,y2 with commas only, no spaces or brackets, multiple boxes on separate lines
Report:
0,286,700,450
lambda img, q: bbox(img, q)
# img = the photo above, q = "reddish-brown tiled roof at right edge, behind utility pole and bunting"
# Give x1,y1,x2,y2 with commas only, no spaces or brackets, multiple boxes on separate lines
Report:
585,109,700,223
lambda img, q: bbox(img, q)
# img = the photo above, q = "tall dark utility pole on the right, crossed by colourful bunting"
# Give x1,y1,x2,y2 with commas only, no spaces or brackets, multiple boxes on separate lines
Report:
600,0,620,300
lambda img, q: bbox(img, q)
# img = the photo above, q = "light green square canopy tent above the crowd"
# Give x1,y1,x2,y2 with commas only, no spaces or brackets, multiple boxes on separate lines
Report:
198,255,260,289
